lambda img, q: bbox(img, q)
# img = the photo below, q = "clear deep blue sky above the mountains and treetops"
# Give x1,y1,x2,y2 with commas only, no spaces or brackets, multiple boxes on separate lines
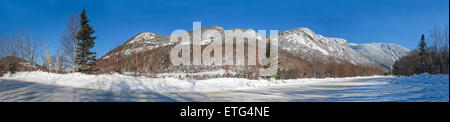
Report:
0,0,449,57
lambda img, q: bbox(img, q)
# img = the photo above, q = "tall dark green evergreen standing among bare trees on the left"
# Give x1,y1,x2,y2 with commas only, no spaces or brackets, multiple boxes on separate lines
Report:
77,9,97,73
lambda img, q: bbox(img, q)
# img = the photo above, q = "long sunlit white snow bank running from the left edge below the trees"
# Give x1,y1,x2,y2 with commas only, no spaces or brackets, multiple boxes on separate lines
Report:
0,71,384,93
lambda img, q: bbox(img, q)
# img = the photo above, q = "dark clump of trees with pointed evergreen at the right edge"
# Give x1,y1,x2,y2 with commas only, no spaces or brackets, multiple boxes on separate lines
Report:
392,27,449,76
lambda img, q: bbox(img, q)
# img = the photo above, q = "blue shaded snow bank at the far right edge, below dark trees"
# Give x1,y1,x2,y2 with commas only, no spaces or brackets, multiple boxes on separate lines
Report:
390,73,449,101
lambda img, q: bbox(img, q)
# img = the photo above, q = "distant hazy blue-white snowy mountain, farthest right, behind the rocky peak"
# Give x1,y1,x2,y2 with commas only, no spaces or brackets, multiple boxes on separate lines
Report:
349,43,410,69
